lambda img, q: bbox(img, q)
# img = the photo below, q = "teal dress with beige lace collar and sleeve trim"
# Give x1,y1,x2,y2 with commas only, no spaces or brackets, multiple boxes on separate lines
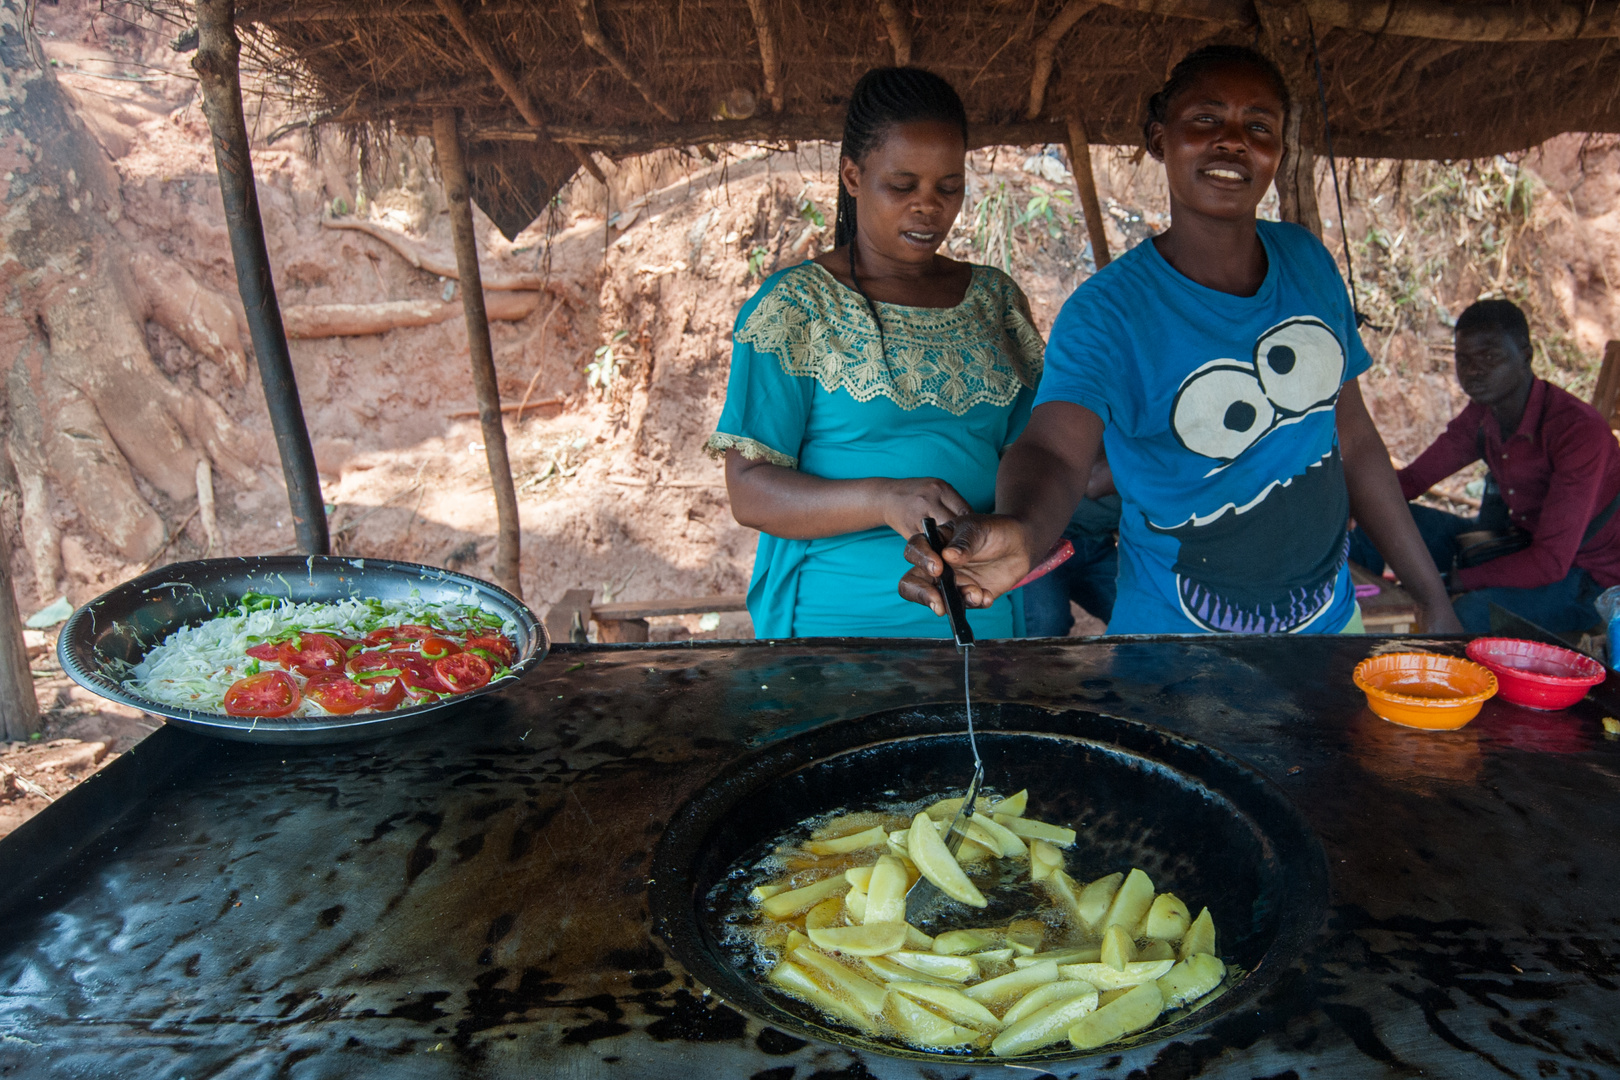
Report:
706,262,1045,638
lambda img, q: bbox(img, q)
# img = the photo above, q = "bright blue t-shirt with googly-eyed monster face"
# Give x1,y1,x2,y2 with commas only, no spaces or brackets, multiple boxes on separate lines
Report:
1035,222,1371,633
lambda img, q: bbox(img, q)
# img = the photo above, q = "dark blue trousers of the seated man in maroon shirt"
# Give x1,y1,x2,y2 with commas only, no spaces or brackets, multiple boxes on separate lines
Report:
1347,505,1602,633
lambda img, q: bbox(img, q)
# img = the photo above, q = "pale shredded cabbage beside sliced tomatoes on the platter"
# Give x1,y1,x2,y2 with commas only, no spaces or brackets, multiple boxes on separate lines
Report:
123,591,517,719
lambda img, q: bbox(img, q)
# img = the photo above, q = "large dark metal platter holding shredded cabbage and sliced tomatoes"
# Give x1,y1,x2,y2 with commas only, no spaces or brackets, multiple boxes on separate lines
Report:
57,555,551,743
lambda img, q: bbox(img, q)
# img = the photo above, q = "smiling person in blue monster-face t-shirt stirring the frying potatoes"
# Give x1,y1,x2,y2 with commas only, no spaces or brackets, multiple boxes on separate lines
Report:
901,45,1461,633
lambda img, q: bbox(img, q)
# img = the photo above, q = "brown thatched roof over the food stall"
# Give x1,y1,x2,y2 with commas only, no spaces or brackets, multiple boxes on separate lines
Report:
238,0,1620,236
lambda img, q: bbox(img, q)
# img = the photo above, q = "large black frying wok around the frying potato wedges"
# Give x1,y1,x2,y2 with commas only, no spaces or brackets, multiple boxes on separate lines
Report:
650,704,1327,1065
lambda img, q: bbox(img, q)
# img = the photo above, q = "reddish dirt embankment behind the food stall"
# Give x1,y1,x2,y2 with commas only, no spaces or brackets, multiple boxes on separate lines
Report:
0,0,1620,831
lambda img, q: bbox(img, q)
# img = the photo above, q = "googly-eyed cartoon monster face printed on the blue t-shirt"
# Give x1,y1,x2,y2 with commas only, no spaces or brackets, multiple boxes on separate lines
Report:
1147,317,1349,633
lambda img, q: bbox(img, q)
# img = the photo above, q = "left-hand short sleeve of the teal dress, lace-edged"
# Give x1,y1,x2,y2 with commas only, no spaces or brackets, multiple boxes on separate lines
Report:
703,280,815,468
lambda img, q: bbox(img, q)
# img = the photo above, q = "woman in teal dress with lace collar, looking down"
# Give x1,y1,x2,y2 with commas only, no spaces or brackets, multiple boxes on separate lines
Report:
708,68,1043,638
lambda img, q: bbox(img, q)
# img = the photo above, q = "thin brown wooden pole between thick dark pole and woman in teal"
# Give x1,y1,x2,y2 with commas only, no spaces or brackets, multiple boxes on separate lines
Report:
433,105,523,599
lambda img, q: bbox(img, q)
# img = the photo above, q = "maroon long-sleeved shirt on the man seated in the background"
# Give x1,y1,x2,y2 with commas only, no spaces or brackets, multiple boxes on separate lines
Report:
1400,379,1620,589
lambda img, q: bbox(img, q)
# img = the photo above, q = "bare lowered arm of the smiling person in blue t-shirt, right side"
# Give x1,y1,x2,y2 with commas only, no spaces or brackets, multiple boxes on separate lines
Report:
1335,379,1463,633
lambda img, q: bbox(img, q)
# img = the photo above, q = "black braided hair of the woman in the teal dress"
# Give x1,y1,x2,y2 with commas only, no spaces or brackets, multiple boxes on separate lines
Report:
833,68,967,348
